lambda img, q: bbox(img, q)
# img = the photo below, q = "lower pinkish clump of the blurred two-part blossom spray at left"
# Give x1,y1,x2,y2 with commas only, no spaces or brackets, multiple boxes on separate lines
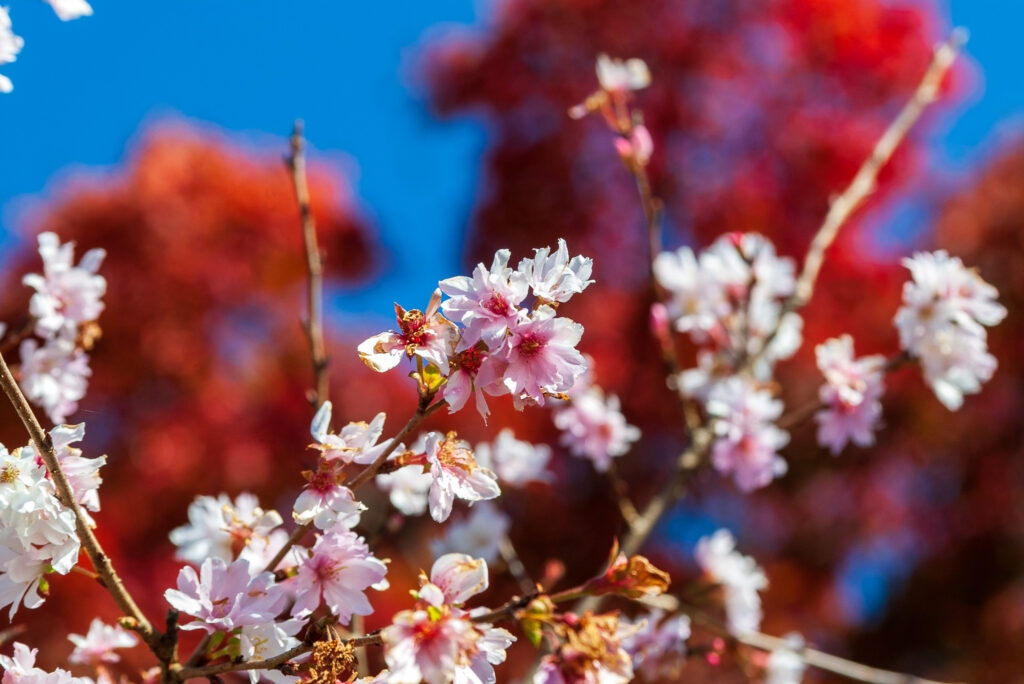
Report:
19,338,92,423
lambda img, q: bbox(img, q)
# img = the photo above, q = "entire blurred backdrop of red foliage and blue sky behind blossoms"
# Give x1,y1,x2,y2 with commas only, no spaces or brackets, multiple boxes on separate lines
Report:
0,0,1024,683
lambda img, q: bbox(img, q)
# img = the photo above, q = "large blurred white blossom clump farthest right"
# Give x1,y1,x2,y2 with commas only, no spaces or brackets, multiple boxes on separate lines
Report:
895,250,1007,411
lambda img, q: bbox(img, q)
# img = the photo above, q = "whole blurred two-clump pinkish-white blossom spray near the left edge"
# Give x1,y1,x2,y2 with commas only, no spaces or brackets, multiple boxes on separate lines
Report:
19,232,106,423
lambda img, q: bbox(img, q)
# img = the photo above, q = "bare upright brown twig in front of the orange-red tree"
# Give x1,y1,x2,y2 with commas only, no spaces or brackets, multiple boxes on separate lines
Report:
285,121,330,409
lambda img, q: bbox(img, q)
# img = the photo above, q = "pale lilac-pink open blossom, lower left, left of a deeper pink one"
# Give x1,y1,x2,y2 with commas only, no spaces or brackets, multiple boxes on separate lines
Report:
164,558,287,634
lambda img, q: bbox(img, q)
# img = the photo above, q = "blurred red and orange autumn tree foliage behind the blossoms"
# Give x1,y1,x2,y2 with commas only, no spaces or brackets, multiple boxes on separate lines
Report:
0,0,1024,682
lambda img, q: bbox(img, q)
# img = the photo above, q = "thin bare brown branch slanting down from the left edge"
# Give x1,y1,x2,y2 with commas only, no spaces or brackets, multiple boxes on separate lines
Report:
0,353,157,647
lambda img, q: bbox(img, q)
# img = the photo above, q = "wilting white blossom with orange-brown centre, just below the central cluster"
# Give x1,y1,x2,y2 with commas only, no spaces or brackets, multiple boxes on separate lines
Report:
424,432,502,522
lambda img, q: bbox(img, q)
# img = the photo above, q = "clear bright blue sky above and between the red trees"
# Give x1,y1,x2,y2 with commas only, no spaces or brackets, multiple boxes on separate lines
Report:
0,0,1024,312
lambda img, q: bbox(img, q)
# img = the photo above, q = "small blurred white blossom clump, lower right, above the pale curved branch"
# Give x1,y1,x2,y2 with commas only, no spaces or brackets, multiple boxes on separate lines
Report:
696,529,768,636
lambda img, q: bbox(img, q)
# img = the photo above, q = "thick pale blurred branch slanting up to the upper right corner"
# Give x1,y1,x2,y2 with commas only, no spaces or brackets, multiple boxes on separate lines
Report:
742,29,967,371
